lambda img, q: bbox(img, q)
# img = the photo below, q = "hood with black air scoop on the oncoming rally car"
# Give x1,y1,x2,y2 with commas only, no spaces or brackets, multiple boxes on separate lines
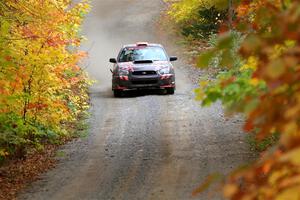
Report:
118,61,172,71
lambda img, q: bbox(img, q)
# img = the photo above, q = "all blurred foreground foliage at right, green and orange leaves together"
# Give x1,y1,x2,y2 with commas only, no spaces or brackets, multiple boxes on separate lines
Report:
169,0,300,200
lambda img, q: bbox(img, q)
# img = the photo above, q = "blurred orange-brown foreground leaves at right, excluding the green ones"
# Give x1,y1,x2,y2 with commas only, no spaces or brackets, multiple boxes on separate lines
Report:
224,0,300,200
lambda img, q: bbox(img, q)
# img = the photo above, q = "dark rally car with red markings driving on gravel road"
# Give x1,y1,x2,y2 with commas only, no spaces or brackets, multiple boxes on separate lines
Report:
109,42,177,97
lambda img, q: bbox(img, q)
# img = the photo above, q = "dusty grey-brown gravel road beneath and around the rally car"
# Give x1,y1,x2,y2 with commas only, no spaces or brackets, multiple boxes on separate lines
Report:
18,0,252,200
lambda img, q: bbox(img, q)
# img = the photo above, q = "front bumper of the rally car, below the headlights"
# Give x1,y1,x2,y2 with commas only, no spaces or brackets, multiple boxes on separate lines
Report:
112,74,175,90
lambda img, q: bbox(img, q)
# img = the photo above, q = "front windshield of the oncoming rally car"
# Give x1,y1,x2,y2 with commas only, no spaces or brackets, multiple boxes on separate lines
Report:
119,47,168,62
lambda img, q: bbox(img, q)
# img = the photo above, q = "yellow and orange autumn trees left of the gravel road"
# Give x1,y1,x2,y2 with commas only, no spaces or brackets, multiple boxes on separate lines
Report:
0,0,89,160
